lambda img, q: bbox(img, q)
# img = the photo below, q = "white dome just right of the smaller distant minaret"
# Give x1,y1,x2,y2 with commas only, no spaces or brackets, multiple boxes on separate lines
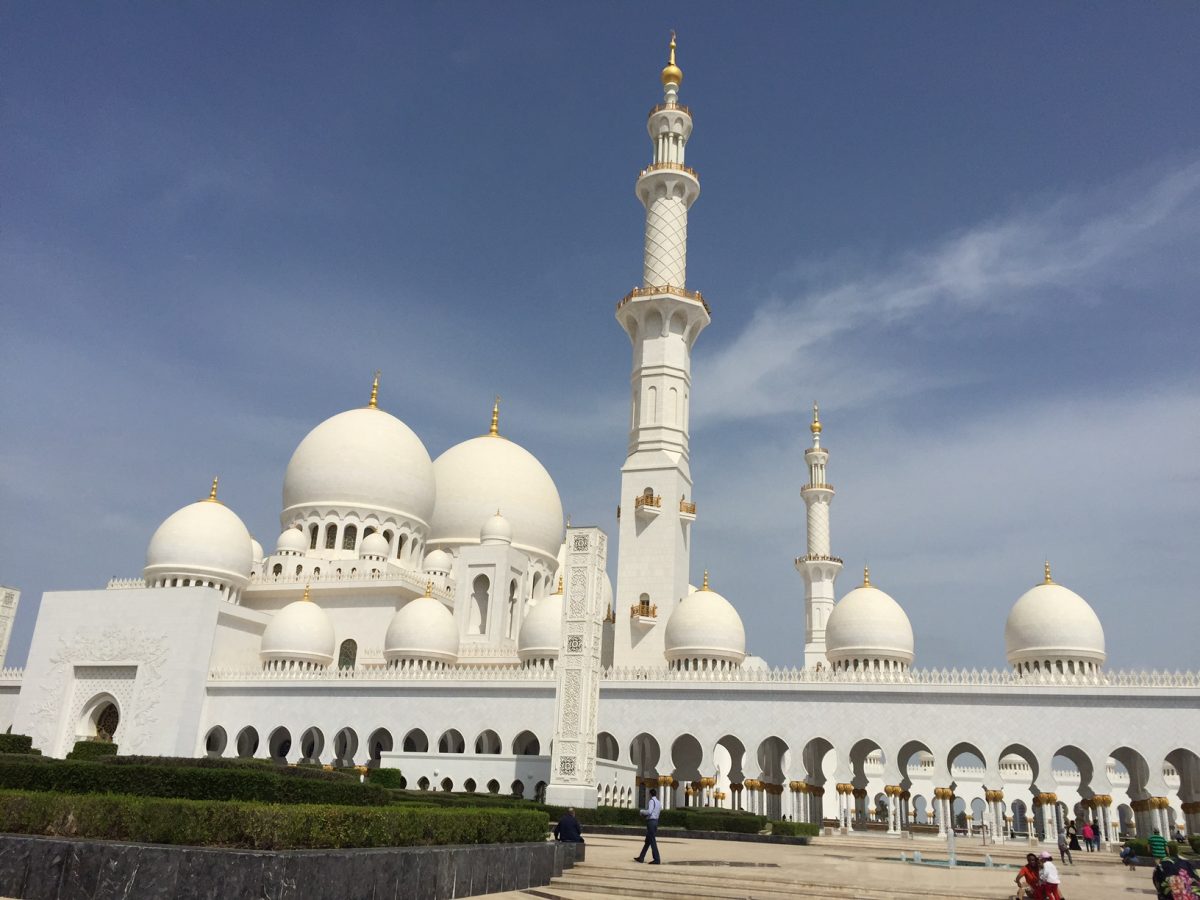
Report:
826,580,913,666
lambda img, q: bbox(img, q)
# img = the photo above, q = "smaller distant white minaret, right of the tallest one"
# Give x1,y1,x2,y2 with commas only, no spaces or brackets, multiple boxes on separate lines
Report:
796,403,841,668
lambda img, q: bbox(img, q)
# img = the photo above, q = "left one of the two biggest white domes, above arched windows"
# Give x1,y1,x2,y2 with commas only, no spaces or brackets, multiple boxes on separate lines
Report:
282,407,436,530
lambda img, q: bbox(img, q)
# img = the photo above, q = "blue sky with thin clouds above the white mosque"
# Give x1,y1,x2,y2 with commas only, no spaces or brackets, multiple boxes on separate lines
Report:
0,2,1200,668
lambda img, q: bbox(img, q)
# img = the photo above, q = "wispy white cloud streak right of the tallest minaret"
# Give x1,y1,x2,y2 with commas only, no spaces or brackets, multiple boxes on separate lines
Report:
696,161,1200,421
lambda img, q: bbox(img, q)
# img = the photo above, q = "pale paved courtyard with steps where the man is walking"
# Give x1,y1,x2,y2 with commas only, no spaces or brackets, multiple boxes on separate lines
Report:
472,835,1154,900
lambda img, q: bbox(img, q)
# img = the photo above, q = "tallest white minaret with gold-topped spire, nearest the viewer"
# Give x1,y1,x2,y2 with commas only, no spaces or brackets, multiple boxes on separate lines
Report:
613,34,709,666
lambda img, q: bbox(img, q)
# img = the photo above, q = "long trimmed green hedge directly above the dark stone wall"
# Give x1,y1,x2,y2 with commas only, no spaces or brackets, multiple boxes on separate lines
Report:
0,791,548,850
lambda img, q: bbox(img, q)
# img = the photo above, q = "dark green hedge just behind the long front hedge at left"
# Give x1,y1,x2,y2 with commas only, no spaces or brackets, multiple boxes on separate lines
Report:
0,762,391,806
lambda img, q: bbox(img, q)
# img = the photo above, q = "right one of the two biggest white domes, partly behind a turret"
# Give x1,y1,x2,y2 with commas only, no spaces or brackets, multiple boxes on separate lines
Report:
427,434,563,562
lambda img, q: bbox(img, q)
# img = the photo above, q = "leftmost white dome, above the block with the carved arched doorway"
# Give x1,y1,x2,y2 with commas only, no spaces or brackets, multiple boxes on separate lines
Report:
143,488,254,588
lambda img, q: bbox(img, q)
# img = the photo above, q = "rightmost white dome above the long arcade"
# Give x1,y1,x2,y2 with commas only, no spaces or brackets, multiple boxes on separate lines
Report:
1004,565,1105,668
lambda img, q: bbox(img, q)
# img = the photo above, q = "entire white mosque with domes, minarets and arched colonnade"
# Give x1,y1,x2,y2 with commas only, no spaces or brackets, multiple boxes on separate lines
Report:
0,37,1200,841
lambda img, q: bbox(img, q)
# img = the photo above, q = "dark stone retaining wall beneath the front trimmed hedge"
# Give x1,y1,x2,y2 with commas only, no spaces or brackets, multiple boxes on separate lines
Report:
0,834,576,900
